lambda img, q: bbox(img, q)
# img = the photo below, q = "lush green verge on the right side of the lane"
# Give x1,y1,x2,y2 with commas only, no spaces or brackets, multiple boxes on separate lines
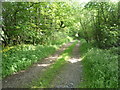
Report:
80,41,118,88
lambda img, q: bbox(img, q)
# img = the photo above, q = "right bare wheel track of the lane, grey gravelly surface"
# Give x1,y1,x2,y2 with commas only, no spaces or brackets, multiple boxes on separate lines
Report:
51,43,82,88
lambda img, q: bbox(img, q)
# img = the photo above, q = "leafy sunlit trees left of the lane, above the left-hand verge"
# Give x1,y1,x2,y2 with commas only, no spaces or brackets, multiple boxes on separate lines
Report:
2,2,74,46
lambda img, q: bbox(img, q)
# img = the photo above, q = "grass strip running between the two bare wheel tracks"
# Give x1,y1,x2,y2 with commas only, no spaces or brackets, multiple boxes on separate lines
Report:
30,42,77,88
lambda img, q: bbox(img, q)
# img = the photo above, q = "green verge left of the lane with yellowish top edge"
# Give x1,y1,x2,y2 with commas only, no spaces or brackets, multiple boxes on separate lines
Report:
2,45,58,78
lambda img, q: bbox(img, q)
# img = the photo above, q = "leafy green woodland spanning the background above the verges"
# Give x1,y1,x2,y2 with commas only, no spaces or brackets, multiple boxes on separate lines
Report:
1,2,120,48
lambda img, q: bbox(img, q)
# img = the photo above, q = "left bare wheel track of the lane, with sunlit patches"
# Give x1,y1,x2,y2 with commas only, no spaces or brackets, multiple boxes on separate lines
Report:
2,42,73,88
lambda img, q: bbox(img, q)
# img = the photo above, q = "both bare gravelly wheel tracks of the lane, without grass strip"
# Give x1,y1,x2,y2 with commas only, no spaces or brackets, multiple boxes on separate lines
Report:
2,42,83,88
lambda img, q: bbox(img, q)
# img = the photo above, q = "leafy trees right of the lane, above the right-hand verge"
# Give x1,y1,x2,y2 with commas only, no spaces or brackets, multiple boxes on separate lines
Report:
76,1,120,49
